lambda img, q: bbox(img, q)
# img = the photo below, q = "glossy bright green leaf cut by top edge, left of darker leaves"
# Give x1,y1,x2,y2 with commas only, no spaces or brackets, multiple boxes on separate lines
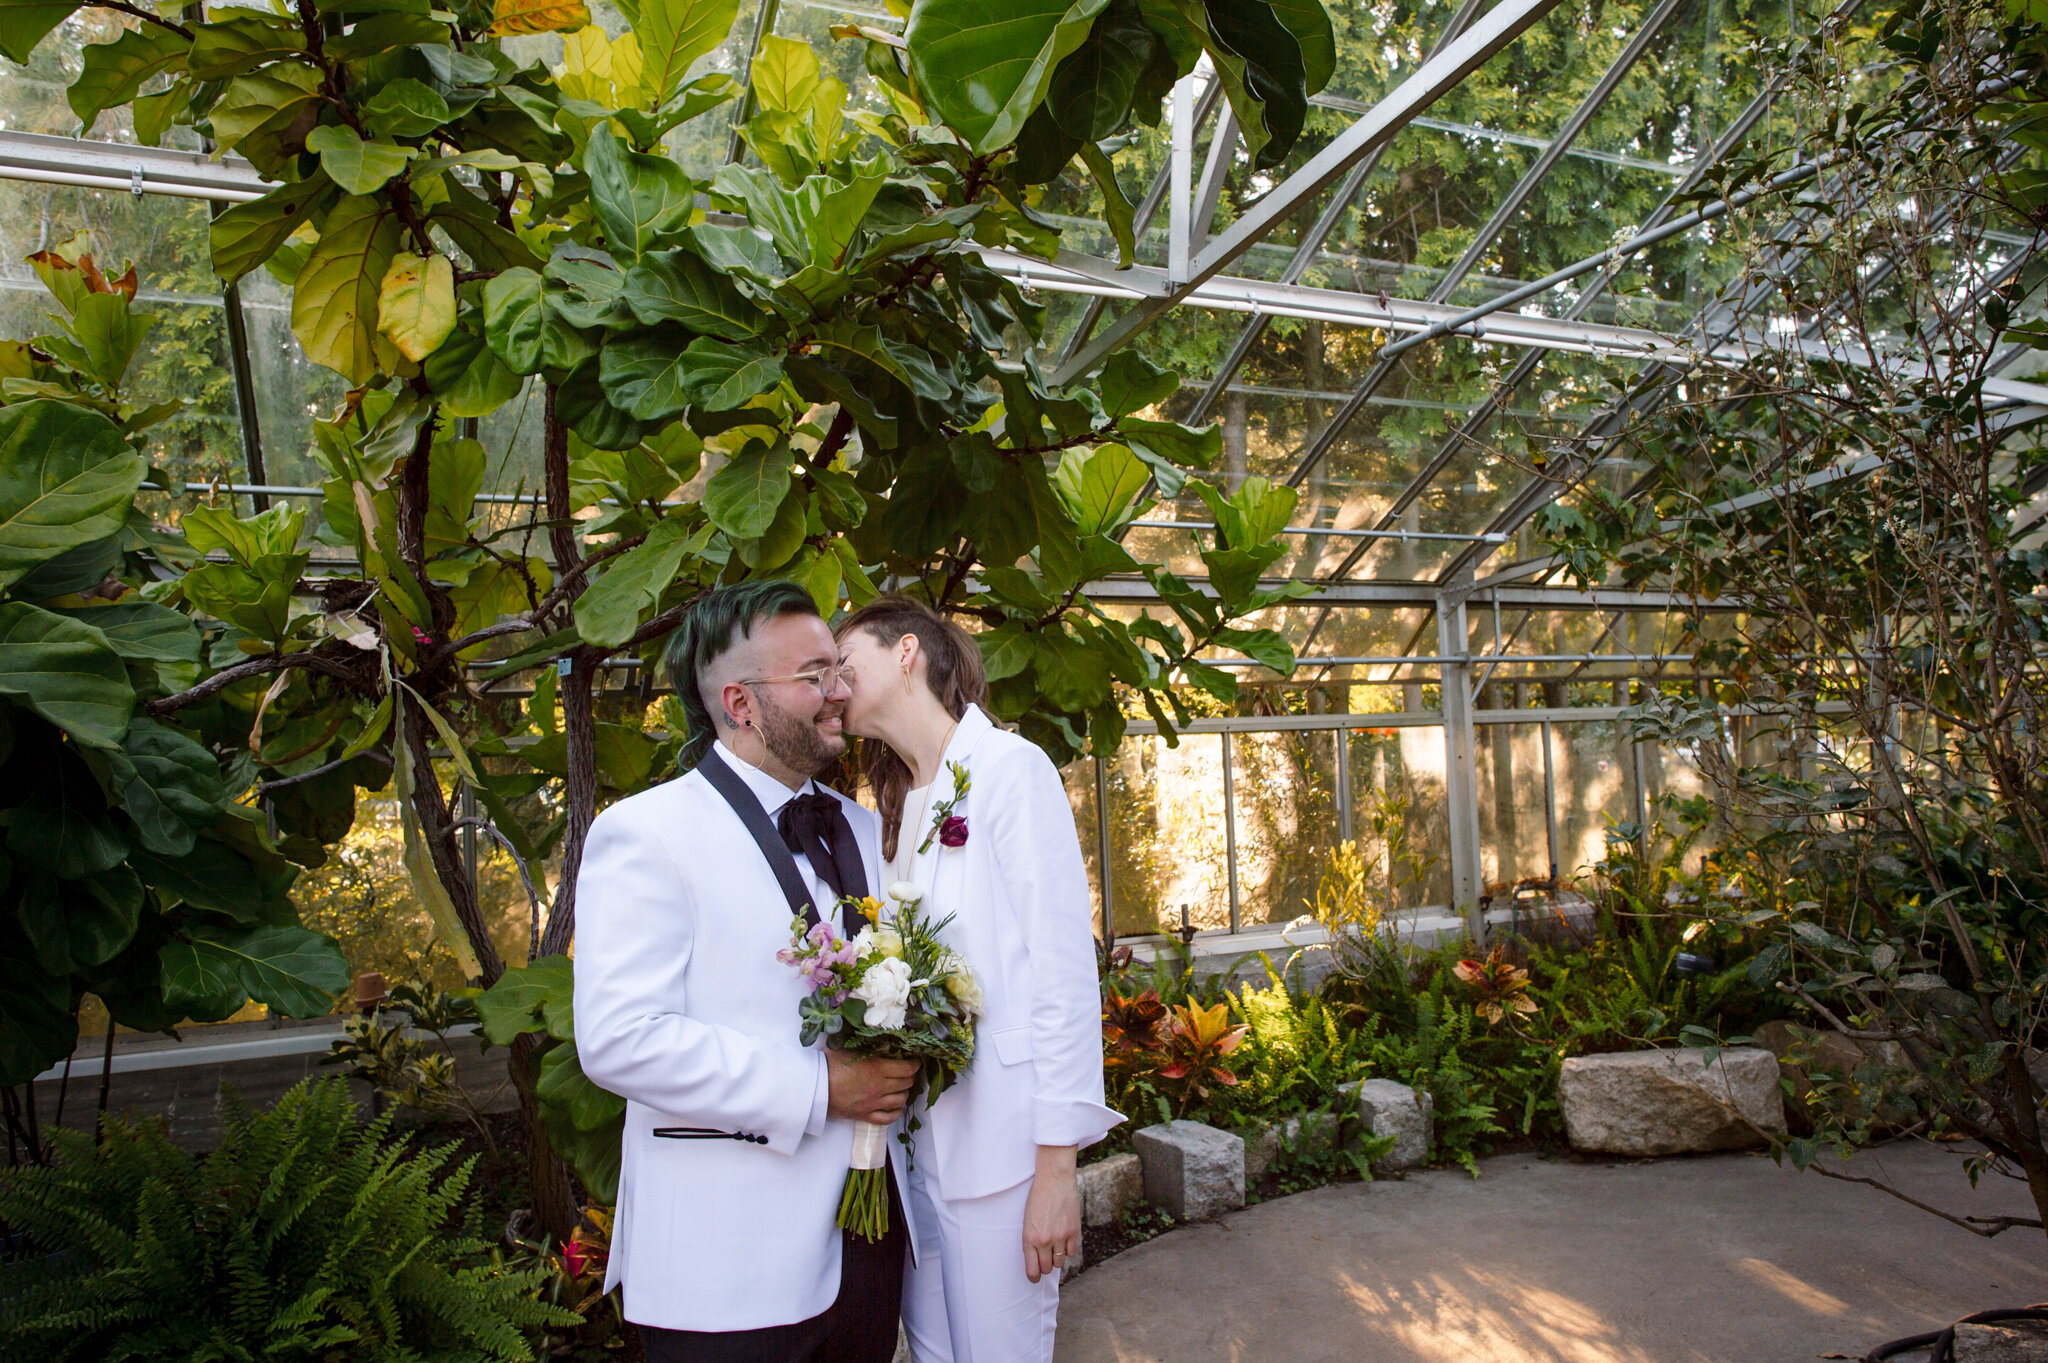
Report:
903,0,1110,153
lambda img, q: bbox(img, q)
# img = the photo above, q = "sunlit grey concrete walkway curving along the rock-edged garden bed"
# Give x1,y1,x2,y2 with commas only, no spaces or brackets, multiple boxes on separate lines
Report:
1057,1146,2048,1363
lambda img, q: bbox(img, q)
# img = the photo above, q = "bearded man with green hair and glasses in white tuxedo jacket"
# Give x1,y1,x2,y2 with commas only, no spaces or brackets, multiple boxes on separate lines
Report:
575,581,915,1363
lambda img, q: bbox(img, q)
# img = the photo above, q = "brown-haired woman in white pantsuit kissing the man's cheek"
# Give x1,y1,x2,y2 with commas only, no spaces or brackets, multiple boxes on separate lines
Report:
838,598,1122,1363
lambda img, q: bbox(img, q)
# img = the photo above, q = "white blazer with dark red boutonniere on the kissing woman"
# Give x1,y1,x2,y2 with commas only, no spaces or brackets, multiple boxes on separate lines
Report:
897,706,1122,1201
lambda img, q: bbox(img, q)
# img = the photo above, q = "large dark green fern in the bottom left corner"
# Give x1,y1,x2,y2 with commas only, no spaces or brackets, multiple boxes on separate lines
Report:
0,1079,578,1363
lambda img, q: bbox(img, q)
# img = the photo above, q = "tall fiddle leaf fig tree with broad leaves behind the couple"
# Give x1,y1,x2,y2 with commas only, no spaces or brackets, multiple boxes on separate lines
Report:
0,0,1329,1232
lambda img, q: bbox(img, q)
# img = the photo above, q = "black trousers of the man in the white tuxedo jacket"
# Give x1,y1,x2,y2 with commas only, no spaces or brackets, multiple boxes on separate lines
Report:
635,1169,909,1363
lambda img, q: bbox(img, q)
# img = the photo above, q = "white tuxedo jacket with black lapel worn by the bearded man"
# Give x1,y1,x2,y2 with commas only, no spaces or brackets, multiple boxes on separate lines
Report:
575,745,893,1330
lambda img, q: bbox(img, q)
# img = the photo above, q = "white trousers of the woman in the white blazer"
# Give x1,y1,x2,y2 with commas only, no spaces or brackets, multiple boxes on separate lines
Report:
903,1169,1059,1363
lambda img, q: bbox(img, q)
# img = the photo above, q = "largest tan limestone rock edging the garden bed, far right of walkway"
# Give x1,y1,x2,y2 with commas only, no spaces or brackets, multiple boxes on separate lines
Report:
1556,1046,1786,1154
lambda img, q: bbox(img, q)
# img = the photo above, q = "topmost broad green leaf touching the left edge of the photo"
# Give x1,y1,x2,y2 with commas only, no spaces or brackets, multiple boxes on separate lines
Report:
0,392,147,587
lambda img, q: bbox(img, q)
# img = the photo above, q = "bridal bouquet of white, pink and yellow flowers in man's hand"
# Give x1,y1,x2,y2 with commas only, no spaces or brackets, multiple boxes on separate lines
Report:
776,880,981,1240
